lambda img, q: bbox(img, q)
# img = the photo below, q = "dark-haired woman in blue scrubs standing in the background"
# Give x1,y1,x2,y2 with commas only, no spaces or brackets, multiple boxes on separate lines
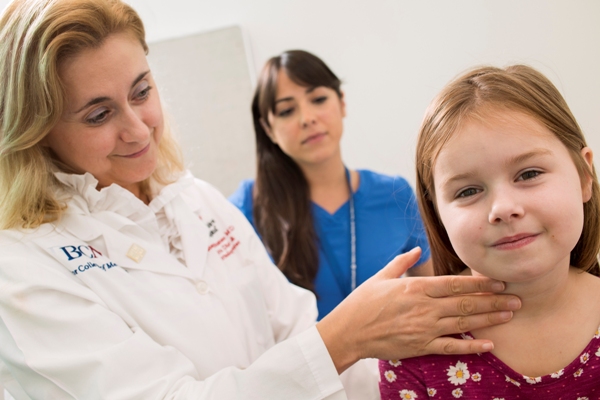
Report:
230,50,431,318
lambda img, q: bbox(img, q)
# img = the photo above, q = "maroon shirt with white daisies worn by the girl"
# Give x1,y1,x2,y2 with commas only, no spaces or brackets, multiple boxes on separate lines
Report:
379,328,600,400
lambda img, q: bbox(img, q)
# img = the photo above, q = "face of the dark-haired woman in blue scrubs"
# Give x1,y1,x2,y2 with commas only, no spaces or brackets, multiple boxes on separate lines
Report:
263,70,346,167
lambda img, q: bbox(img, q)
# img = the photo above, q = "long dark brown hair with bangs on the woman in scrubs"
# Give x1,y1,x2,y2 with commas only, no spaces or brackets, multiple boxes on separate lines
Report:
252,50,341,292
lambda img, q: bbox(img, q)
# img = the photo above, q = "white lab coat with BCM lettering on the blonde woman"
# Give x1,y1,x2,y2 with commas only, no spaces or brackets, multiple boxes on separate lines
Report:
0,173,378,400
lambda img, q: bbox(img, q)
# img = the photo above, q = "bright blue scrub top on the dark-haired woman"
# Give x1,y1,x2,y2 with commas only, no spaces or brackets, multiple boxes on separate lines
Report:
229,170,430,319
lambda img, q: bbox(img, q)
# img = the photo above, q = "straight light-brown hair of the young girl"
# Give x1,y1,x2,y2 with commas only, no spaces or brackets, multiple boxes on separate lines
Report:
416,65,600,275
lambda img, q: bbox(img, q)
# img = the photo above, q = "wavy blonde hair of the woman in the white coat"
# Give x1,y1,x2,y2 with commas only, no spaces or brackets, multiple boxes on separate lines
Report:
0,0,183,229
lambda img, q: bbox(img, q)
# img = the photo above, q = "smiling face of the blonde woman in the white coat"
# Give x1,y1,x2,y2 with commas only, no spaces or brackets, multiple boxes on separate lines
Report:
42,33,164,197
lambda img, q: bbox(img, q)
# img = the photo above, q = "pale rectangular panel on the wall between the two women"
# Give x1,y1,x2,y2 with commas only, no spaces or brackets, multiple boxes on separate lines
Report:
148,26,256,194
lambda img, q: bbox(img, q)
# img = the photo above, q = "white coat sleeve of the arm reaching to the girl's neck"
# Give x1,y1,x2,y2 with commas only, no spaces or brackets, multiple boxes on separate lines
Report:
0,253,346,400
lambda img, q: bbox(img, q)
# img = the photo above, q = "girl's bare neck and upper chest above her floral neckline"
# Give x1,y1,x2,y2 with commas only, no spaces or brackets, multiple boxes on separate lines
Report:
471,267,600,377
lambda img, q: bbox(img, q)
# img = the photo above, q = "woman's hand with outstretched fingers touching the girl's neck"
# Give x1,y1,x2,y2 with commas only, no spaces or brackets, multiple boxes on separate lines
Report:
317,248,521,373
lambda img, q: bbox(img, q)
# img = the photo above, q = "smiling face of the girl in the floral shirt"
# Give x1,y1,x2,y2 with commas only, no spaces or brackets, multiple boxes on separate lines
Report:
433,111,592,282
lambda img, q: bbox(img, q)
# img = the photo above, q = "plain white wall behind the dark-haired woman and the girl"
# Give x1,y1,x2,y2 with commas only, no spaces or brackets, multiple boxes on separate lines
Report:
129,0,600,188
